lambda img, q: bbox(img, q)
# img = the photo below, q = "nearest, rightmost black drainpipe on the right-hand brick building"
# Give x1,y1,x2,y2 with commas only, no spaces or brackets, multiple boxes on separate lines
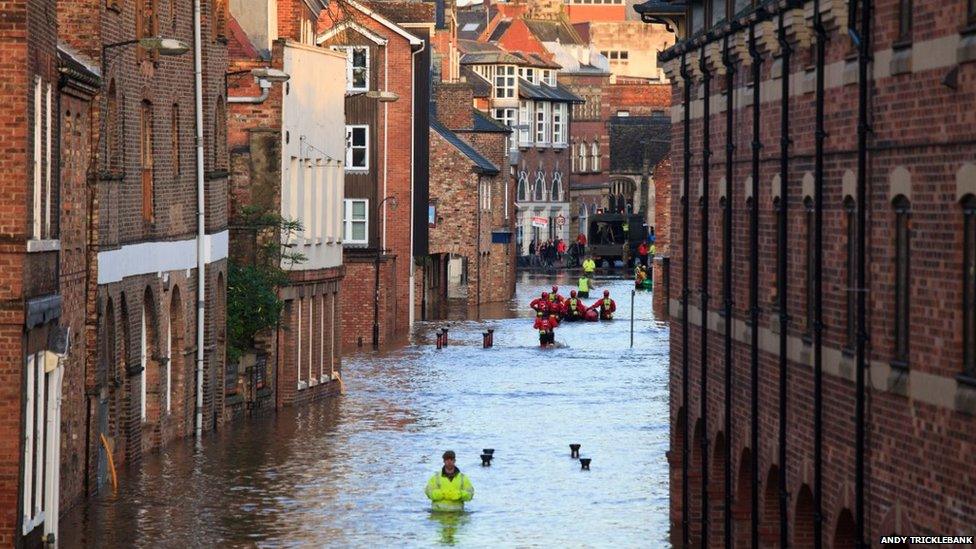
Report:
849,0,871,547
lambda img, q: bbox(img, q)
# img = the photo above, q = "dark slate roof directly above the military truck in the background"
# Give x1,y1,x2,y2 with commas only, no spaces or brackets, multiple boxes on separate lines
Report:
610,114,671,173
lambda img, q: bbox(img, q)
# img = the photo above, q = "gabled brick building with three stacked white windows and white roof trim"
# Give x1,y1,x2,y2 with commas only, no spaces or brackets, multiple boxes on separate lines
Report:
316,0,435,348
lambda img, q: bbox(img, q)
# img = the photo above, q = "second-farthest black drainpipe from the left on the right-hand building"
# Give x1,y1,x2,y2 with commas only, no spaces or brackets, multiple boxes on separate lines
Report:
698,46,712,547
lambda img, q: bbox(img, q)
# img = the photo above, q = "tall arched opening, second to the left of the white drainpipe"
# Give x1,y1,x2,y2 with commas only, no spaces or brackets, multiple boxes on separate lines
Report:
139,286,165,451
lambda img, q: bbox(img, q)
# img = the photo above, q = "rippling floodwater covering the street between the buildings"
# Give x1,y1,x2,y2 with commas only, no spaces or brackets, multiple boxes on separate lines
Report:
61,275,669,548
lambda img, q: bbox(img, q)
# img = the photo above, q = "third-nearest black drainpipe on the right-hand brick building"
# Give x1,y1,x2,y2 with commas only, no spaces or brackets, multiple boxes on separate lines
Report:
776,11,792,547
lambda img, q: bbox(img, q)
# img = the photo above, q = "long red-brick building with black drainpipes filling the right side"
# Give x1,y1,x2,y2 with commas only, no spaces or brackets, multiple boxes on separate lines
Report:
638,0,976,547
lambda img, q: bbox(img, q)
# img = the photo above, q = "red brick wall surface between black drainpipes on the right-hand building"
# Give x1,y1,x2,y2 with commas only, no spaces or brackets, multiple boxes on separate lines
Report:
656,0,976,547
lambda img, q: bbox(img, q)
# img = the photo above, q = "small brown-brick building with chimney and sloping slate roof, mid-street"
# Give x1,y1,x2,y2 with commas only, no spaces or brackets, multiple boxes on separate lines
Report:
423,83,517,317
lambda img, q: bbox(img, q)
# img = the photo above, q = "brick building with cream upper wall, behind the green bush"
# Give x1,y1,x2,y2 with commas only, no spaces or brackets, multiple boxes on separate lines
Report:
225,0,346,413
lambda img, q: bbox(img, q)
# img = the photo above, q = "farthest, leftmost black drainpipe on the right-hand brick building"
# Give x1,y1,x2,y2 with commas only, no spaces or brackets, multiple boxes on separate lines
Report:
681,55,692,547
